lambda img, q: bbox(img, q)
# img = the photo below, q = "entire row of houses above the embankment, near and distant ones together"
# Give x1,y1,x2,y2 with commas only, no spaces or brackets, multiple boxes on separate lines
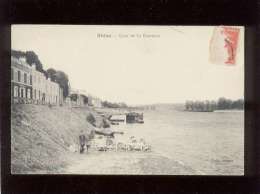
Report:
11,56,102,107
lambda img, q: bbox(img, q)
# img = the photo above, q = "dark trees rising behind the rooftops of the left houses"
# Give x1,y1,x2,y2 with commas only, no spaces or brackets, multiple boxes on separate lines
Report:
11,50,69,97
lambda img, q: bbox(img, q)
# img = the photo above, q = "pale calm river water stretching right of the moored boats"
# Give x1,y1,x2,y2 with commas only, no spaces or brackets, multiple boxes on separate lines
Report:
113,109,244,175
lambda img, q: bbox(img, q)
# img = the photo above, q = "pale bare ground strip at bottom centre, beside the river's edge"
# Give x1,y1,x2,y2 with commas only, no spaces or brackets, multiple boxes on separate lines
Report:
62,151,196,175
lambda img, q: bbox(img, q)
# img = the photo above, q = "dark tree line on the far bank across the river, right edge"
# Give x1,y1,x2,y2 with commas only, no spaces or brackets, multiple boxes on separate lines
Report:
185,97,244,111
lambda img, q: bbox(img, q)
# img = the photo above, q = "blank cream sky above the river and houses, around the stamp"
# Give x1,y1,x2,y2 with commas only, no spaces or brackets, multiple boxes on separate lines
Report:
11,25,244,105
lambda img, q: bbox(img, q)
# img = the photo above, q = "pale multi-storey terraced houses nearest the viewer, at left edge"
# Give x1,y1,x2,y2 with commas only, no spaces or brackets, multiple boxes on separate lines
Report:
11,56,63,105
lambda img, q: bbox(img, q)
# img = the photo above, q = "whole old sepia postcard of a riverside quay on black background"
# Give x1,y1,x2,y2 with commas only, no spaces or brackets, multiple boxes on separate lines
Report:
11,24,244,176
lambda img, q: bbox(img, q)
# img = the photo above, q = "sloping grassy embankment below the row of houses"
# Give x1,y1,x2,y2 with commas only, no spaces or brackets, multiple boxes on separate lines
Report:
11,104,106,174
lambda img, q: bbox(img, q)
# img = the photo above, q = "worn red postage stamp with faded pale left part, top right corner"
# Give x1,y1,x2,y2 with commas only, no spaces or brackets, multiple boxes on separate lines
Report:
209,26,240,65
